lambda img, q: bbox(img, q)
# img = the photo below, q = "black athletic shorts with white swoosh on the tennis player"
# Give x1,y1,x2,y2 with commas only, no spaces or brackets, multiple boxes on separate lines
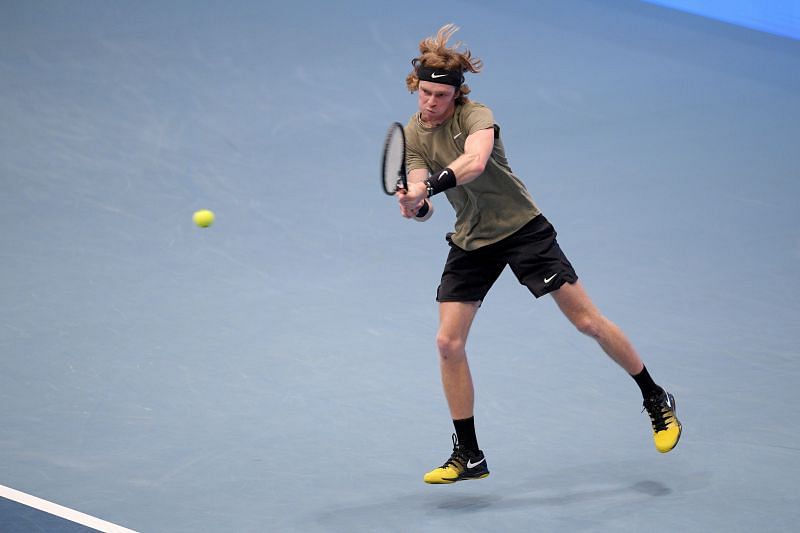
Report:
436,215,578,302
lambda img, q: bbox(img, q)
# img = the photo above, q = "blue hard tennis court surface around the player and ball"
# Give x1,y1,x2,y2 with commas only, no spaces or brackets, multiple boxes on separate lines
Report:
0,0,800,533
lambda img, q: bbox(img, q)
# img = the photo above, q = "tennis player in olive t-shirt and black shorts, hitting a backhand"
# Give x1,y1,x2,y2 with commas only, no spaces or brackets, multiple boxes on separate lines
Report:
398,24,681,483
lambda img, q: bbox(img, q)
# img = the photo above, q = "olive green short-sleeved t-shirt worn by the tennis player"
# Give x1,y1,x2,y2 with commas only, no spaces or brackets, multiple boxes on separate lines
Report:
405,102,540,250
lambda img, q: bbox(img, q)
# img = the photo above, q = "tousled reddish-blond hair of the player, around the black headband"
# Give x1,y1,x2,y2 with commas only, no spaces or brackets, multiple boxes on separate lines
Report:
406,23,483,104
